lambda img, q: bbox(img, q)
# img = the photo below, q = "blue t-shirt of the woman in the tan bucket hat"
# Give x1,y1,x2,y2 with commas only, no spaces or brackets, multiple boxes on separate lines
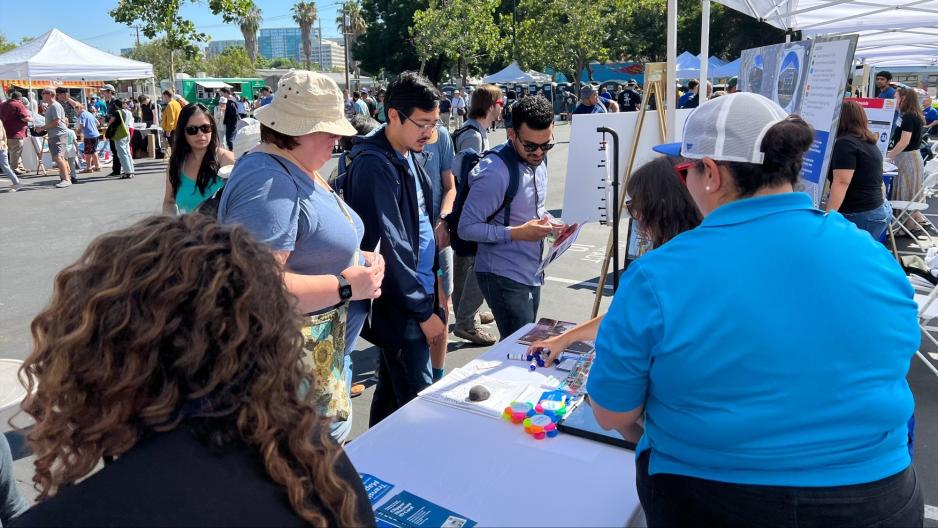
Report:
218,152,368,353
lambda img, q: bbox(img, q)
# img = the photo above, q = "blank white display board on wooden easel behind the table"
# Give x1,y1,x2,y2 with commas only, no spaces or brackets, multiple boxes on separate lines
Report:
562,110,691,225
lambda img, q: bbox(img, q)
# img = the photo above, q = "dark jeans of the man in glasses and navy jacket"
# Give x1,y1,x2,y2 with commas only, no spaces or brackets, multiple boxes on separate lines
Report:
368,319,433,427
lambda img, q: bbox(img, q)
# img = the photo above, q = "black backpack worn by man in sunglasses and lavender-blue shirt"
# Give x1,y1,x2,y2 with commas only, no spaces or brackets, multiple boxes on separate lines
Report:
446,139,521,257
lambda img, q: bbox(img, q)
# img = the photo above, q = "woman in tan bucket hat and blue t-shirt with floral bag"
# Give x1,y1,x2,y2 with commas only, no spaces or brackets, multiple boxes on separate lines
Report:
218,70,384,442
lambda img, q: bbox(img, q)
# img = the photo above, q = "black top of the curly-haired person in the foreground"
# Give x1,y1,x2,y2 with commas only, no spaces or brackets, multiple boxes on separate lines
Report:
11,427,375,527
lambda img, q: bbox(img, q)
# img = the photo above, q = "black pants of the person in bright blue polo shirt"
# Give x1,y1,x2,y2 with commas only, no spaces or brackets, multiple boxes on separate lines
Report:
635,451,925,528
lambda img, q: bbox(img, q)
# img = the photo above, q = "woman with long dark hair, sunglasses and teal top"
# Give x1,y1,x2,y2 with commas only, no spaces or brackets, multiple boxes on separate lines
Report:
163,103,234,214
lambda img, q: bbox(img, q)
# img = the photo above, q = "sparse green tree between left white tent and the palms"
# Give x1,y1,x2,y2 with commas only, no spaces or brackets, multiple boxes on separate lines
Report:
108,0,254,82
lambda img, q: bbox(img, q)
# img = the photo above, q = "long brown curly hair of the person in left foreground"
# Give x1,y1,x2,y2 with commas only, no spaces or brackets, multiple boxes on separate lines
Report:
20,215,361,526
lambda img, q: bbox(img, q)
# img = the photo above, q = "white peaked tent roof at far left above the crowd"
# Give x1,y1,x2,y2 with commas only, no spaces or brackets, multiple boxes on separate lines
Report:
0,28,153,81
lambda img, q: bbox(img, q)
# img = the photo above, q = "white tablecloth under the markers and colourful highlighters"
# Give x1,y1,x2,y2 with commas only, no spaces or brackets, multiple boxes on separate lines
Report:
345,325,639,526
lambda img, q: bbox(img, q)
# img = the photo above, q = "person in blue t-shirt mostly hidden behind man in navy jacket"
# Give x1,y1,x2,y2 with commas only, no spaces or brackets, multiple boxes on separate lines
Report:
413,122,456,382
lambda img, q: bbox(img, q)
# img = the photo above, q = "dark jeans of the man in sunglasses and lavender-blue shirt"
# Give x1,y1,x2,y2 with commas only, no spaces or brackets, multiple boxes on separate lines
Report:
476,271,541,339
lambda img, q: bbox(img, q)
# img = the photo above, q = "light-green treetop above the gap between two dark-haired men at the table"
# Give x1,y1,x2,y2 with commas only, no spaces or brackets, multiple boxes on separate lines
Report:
410,0,505,81
